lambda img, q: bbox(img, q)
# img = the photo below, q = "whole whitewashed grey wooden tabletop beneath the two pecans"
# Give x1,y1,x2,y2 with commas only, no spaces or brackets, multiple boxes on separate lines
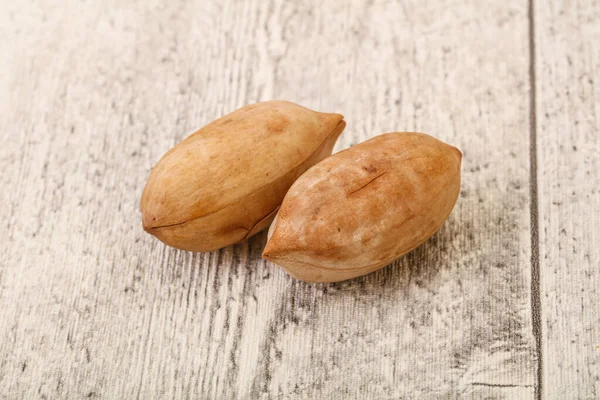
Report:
0,0,600,399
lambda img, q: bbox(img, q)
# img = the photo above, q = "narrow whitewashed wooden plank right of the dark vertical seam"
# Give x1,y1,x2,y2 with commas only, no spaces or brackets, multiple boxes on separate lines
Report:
535,0,600,399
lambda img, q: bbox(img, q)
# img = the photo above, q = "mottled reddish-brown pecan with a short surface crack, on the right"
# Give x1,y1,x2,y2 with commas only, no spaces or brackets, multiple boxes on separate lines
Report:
263,133,462,282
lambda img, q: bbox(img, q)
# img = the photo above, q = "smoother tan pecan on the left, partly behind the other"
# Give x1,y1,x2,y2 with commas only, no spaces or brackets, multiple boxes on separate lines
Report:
141,101,345,251
